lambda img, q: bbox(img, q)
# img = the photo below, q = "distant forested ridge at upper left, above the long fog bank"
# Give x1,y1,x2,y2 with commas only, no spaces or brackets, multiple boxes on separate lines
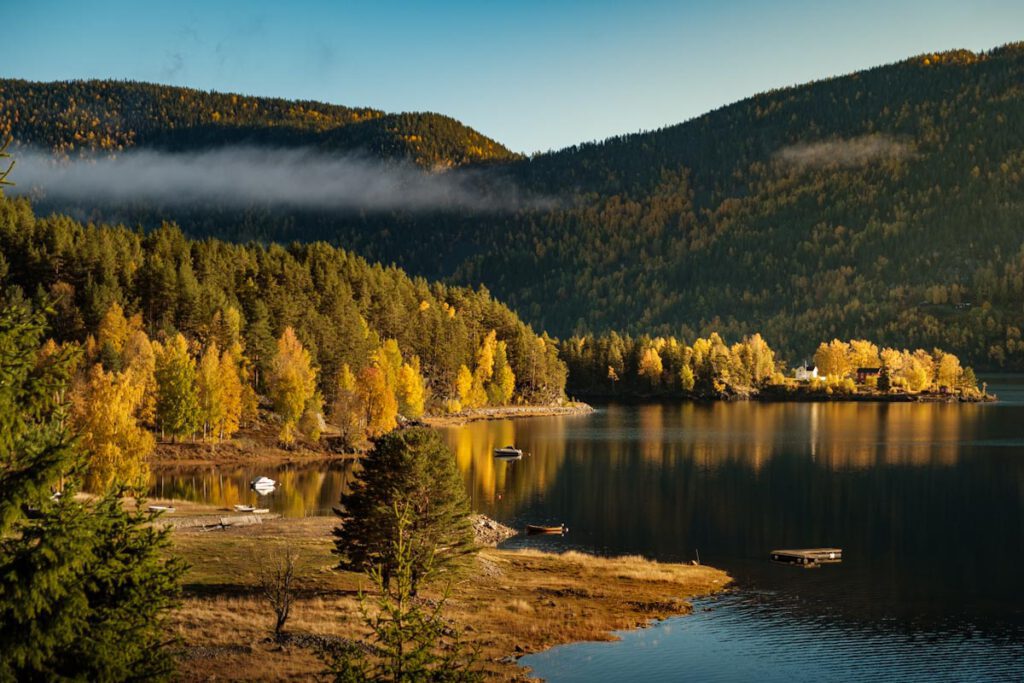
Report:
0,80,515,168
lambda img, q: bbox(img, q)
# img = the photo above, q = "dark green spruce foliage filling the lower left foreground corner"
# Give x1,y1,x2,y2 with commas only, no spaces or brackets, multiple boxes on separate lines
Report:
0,307,185,681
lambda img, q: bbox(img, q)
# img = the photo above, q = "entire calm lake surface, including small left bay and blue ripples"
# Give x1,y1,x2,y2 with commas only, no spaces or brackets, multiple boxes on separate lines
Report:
153,378,1024,681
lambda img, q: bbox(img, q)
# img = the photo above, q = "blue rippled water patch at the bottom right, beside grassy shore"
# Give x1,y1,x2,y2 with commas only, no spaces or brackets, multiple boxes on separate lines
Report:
519,591,1024,683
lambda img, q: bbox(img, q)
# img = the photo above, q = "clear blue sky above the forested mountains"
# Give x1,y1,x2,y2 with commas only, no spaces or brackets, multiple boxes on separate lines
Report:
8,0,1024,153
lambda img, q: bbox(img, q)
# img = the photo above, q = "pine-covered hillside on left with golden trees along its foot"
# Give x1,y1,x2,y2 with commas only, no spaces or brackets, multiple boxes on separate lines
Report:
0,198,566,448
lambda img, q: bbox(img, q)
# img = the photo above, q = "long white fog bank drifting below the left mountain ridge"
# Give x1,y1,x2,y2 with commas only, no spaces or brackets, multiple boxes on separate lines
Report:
9,146,556,211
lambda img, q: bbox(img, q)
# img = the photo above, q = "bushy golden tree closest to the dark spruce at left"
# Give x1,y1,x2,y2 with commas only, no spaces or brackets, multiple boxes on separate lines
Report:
71,364,156,492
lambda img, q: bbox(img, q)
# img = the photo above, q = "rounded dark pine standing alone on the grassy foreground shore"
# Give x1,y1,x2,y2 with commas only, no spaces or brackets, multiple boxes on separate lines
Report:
334,428,475,590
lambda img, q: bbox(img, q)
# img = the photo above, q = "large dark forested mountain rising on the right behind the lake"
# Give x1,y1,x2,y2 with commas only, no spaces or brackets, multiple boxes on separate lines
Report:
4,44,1024,369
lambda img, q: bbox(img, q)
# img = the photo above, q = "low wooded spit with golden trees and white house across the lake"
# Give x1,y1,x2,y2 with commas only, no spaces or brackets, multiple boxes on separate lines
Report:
562,332,990,401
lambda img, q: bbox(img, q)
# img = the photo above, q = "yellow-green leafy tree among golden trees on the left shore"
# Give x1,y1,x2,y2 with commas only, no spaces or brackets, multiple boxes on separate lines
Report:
156,334,201,437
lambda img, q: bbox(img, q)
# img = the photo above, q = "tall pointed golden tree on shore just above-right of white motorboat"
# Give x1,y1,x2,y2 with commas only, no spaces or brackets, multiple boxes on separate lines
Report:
267,327,316,443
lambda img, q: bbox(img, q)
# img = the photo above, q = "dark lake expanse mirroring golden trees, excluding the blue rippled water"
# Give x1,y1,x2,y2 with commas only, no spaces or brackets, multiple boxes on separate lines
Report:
438,393,1024,618
